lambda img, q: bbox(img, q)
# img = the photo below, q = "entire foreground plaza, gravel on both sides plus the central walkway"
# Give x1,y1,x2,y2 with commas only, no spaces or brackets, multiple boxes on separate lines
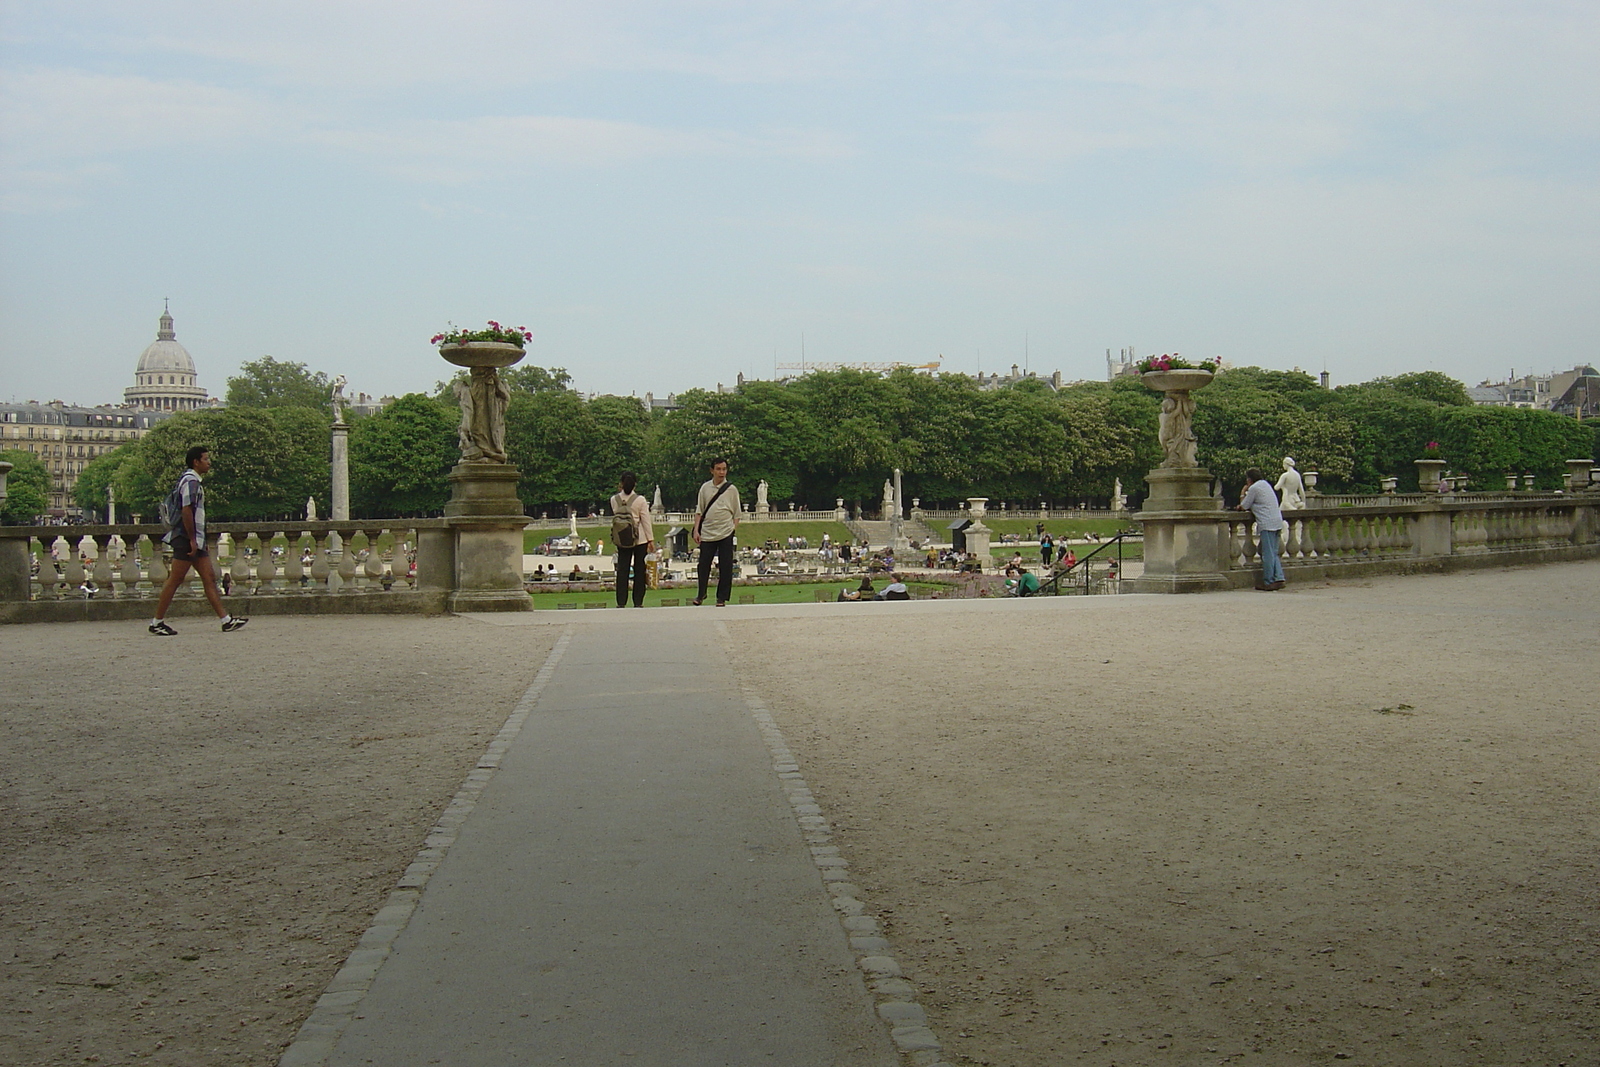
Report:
0,560,1600,1065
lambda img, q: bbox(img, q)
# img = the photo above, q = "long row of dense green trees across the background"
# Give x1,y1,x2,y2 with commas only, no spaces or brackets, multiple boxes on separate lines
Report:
65,358,1597,520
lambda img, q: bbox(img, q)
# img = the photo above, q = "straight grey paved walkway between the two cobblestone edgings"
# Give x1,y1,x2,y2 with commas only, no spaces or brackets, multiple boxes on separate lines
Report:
282,611,915,1067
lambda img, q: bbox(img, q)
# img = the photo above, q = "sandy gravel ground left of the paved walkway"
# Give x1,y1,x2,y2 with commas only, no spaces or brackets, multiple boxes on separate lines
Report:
0,617,557,1067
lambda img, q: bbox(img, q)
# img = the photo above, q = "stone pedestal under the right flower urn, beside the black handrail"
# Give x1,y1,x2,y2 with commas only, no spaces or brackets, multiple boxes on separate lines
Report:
1123,467,1230,593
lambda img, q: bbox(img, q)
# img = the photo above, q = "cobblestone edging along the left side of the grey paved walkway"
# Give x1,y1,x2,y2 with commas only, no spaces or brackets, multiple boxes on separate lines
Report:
278,625,573,1067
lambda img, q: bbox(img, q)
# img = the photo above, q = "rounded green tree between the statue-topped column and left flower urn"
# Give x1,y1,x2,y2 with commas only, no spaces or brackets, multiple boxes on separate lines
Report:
350,394,461,517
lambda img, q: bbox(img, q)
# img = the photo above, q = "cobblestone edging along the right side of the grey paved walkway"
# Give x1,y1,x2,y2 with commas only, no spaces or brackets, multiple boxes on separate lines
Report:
717,622,950,1067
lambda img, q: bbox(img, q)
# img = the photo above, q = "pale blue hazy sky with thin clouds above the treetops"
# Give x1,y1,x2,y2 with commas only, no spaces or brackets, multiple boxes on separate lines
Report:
0,0,1600,405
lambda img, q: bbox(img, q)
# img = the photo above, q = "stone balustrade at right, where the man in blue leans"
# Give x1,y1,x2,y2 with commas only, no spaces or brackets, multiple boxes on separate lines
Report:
1219,493,1600,585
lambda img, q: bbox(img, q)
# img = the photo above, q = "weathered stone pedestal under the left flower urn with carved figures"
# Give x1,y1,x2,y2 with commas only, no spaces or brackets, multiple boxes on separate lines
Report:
445,462,533,611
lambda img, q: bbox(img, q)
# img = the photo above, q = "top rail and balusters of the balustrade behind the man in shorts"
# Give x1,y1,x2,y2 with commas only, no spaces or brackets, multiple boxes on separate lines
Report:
5,518,443,600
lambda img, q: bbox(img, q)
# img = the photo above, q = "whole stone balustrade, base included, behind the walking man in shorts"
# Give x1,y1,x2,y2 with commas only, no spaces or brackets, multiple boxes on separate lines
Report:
0,518,453,621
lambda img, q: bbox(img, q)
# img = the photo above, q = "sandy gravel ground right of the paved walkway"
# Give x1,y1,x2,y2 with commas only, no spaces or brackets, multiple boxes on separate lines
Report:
730,563,1600,1067
